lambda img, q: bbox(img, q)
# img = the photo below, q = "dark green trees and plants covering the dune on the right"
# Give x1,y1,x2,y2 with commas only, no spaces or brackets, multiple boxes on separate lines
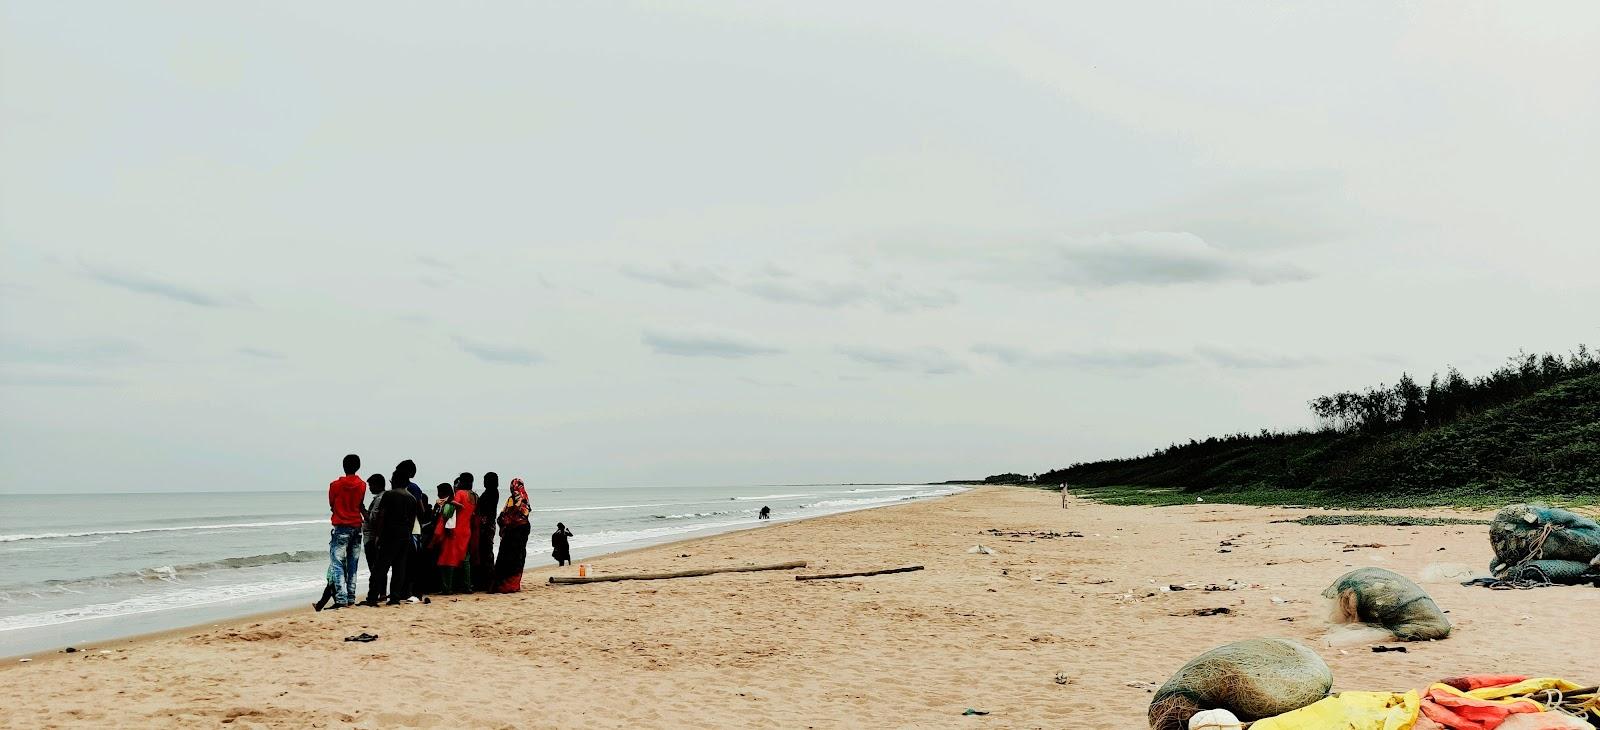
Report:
1032,349,1600,507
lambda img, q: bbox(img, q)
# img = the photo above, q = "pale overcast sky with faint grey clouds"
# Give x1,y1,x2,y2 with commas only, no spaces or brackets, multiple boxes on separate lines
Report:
0,2,1600,493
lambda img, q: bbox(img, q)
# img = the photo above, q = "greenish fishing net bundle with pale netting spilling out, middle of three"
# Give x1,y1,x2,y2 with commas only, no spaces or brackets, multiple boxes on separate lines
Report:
1322,568,1450,642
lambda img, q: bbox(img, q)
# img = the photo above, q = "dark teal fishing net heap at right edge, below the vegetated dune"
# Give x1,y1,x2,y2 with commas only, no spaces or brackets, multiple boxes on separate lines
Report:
1490,504,1600,583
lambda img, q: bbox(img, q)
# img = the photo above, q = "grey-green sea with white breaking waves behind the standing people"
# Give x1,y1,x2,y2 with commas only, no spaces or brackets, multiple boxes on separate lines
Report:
0,483,963,656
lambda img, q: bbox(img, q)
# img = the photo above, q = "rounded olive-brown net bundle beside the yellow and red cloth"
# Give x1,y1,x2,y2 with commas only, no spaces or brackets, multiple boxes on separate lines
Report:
1149,639,1333,730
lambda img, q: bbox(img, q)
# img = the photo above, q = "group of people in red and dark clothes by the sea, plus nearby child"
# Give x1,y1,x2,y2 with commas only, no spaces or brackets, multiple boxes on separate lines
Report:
314,453,573,612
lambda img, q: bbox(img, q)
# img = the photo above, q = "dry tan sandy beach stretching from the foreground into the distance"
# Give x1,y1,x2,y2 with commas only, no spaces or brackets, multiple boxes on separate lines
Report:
0,487,1600,728
